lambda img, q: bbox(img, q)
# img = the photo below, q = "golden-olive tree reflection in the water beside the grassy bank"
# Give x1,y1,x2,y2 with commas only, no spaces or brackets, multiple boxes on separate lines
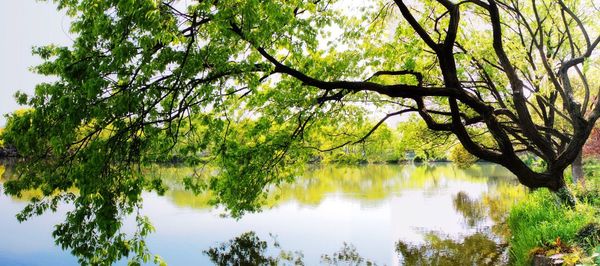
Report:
396,188,522,265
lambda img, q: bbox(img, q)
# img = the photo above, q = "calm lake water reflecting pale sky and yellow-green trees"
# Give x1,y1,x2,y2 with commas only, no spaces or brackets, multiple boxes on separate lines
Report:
0,164,519,265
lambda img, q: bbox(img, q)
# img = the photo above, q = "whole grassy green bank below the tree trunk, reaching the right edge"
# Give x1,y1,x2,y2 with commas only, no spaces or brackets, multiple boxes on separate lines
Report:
507,163,600,265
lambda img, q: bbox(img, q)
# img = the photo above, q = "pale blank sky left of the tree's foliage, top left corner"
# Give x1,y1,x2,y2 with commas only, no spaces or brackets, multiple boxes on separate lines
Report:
0,0,71,127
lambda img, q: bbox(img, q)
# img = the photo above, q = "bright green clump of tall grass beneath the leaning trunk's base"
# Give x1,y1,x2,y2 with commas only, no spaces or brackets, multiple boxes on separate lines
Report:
508,189,595,265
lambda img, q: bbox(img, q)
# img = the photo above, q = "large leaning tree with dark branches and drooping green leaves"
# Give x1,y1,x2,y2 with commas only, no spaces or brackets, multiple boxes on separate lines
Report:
4,0,600,262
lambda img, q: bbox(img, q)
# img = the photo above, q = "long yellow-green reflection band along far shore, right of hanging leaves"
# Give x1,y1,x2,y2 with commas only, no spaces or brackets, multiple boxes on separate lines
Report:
270,163,512,205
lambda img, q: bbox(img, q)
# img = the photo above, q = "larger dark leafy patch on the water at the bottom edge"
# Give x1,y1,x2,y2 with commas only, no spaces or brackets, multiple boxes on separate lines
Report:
204,231,304,266
